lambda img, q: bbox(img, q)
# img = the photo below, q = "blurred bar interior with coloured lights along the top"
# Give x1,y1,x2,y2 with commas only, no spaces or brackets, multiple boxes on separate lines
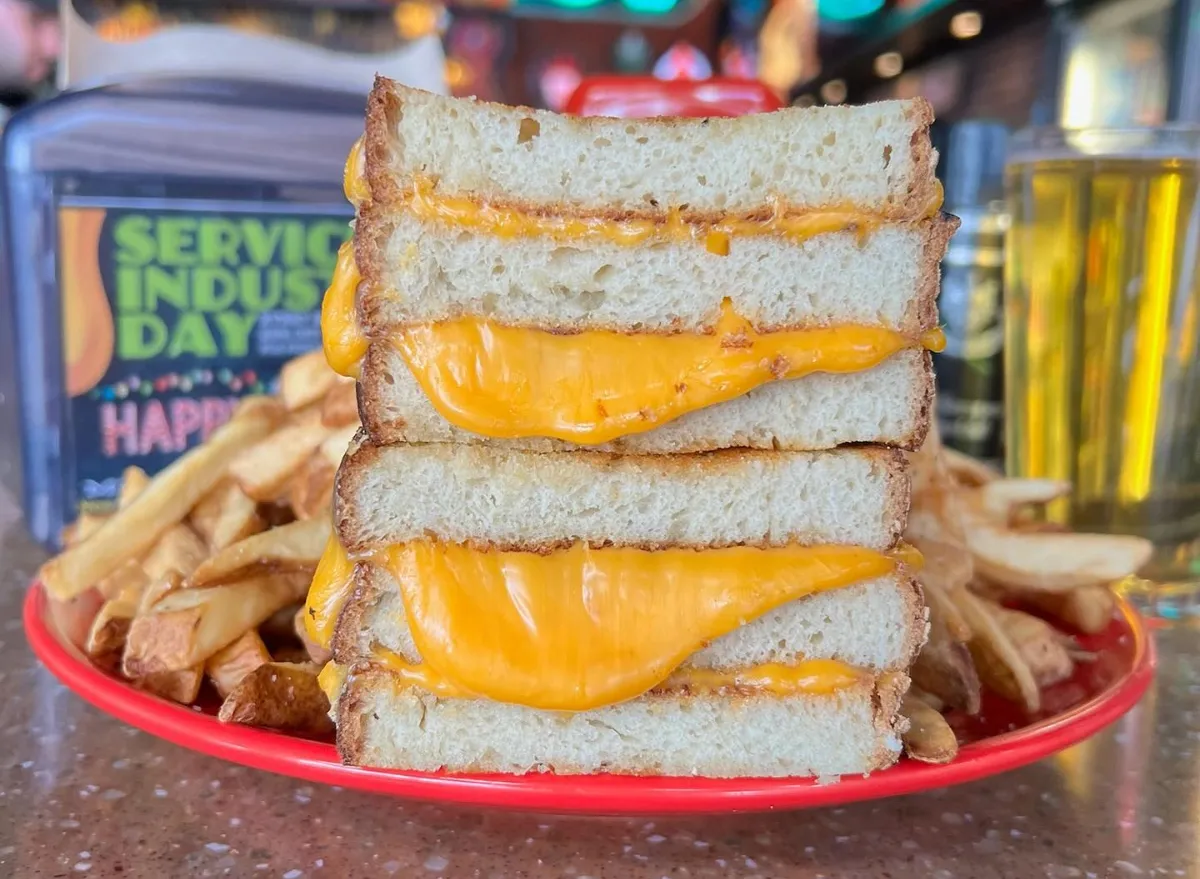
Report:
0,0,1198,126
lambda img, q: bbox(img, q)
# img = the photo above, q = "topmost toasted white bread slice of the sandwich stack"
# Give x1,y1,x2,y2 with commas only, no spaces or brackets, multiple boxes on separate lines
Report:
366,77,937,216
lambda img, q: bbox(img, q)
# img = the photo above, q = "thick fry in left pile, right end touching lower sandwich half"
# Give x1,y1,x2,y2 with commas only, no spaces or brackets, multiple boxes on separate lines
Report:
191,516,332,587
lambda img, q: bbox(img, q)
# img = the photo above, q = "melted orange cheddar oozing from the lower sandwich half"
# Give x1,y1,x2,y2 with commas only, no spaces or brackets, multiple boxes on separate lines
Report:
306,540,912,711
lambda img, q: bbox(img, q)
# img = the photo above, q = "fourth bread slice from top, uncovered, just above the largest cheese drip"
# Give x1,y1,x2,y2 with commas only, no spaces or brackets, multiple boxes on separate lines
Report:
334,442,910,551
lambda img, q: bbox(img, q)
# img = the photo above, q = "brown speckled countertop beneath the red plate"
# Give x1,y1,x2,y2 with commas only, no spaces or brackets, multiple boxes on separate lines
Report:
0,413,1200,879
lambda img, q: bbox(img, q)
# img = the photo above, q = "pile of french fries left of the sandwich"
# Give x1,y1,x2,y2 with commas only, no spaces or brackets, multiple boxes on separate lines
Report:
40,351,359,735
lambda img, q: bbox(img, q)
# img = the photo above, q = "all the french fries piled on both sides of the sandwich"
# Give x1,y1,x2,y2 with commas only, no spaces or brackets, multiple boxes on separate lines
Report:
40,352,1152,763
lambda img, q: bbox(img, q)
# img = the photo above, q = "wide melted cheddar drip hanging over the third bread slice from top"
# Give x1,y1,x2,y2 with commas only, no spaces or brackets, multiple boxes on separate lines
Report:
391,303,943,446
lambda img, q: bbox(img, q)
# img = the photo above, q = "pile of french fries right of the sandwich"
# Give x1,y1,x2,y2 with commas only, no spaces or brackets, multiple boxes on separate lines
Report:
904,430,1153,763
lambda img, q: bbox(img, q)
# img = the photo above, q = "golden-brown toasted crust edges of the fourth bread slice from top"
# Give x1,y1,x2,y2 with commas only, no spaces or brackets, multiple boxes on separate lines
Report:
334,441,912,555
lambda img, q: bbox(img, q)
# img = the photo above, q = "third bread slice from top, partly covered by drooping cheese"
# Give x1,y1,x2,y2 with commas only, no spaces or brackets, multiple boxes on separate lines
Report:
359,341,934,455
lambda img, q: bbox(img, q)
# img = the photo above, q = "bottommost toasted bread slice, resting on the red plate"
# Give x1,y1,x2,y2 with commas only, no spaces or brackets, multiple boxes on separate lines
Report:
334,663,908,778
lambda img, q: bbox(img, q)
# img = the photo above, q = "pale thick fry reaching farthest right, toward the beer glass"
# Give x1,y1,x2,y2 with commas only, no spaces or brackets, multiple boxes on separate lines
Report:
966,521,1153,592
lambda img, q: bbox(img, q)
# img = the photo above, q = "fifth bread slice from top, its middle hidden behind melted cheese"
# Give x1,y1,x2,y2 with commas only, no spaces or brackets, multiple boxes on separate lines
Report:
332,563,928,671
